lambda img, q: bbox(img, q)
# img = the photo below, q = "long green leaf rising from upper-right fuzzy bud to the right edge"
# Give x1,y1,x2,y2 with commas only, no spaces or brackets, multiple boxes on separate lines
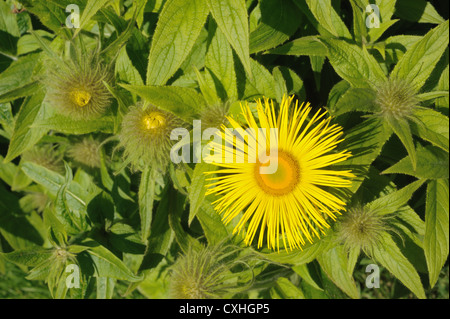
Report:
391,20,449,91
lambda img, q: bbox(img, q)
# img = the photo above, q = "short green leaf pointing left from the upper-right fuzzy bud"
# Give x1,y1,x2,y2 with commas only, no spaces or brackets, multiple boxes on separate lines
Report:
330,88,376,116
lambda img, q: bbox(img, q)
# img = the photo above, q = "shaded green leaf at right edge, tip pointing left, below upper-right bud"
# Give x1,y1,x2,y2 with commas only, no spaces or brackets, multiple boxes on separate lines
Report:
382,145,449,179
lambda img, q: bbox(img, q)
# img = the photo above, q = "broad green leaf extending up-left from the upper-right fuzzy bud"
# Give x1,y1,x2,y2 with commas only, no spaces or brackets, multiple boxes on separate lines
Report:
320,37,386,88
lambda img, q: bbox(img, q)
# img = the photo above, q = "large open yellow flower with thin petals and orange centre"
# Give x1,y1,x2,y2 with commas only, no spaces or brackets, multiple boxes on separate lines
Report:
207,97,354,250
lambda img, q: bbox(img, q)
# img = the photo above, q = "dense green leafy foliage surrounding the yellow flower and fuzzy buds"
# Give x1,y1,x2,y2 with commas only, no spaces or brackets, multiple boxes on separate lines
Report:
0,0,449,298
